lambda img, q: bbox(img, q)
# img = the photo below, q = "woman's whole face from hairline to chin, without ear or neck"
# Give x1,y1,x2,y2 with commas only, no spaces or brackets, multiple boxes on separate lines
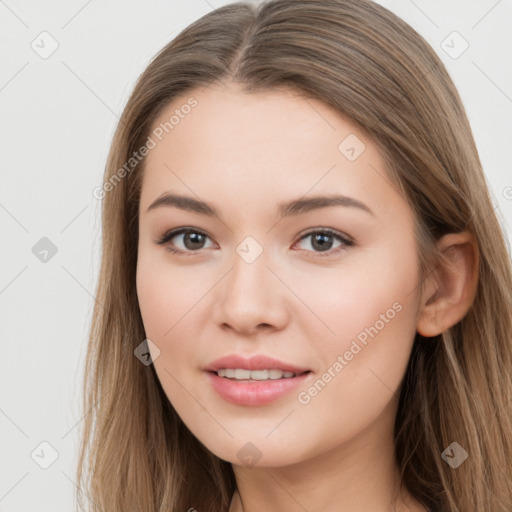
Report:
137,84,419,466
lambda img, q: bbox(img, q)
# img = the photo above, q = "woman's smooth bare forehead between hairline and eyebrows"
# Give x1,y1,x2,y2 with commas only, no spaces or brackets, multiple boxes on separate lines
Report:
141,84,404,221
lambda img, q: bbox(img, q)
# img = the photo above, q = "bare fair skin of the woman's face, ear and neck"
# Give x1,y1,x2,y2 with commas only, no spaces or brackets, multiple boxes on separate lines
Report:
137,84,477,512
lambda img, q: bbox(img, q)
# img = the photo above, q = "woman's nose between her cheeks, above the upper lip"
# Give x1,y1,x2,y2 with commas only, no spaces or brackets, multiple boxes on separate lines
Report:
213,244,289,335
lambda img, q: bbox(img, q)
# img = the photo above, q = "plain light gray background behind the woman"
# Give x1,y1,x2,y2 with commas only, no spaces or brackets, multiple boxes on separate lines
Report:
0,0,512,512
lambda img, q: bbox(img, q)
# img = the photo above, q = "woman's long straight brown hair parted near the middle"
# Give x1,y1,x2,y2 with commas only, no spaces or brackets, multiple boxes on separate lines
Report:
77,0,512,512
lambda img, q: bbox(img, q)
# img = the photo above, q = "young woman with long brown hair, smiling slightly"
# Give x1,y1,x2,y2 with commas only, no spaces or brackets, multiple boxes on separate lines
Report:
78,0,512,512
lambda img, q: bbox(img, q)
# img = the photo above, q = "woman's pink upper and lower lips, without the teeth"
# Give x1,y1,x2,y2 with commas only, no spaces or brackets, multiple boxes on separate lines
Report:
205,354,311,406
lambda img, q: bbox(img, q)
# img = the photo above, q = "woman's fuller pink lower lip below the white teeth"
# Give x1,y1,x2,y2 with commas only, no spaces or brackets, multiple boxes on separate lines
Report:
207,372,311,406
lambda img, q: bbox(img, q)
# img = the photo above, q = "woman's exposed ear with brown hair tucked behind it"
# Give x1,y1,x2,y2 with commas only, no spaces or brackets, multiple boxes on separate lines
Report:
416,231,479,337
